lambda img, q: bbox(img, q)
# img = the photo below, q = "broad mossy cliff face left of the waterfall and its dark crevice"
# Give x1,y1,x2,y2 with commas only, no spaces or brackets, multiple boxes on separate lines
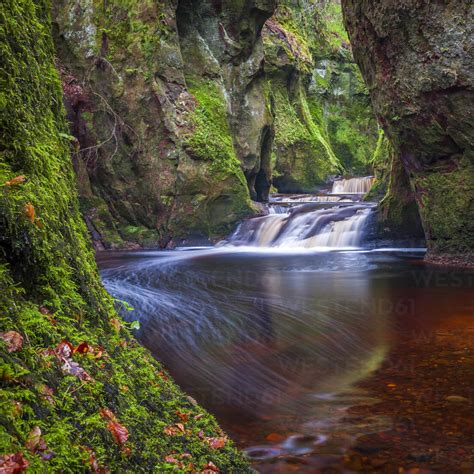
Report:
54,0,274,250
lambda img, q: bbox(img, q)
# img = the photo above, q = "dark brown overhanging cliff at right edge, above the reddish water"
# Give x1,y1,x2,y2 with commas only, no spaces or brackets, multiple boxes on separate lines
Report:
342,0,474,263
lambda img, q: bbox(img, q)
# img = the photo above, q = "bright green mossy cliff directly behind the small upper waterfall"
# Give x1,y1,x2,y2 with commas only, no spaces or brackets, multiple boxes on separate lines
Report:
263,0,377,192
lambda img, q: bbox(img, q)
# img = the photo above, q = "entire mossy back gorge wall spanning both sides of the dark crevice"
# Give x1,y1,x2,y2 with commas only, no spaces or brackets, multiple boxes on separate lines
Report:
53,0,384,248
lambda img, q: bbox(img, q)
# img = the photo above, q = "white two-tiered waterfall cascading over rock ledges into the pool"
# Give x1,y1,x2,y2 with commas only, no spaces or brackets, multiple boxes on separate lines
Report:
224,177,375,248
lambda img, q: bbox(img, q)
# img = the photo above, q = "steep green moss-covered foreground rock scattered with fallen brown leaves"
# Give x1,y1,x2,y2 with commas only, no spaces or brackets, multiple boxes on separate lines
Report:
0,0,250,473
